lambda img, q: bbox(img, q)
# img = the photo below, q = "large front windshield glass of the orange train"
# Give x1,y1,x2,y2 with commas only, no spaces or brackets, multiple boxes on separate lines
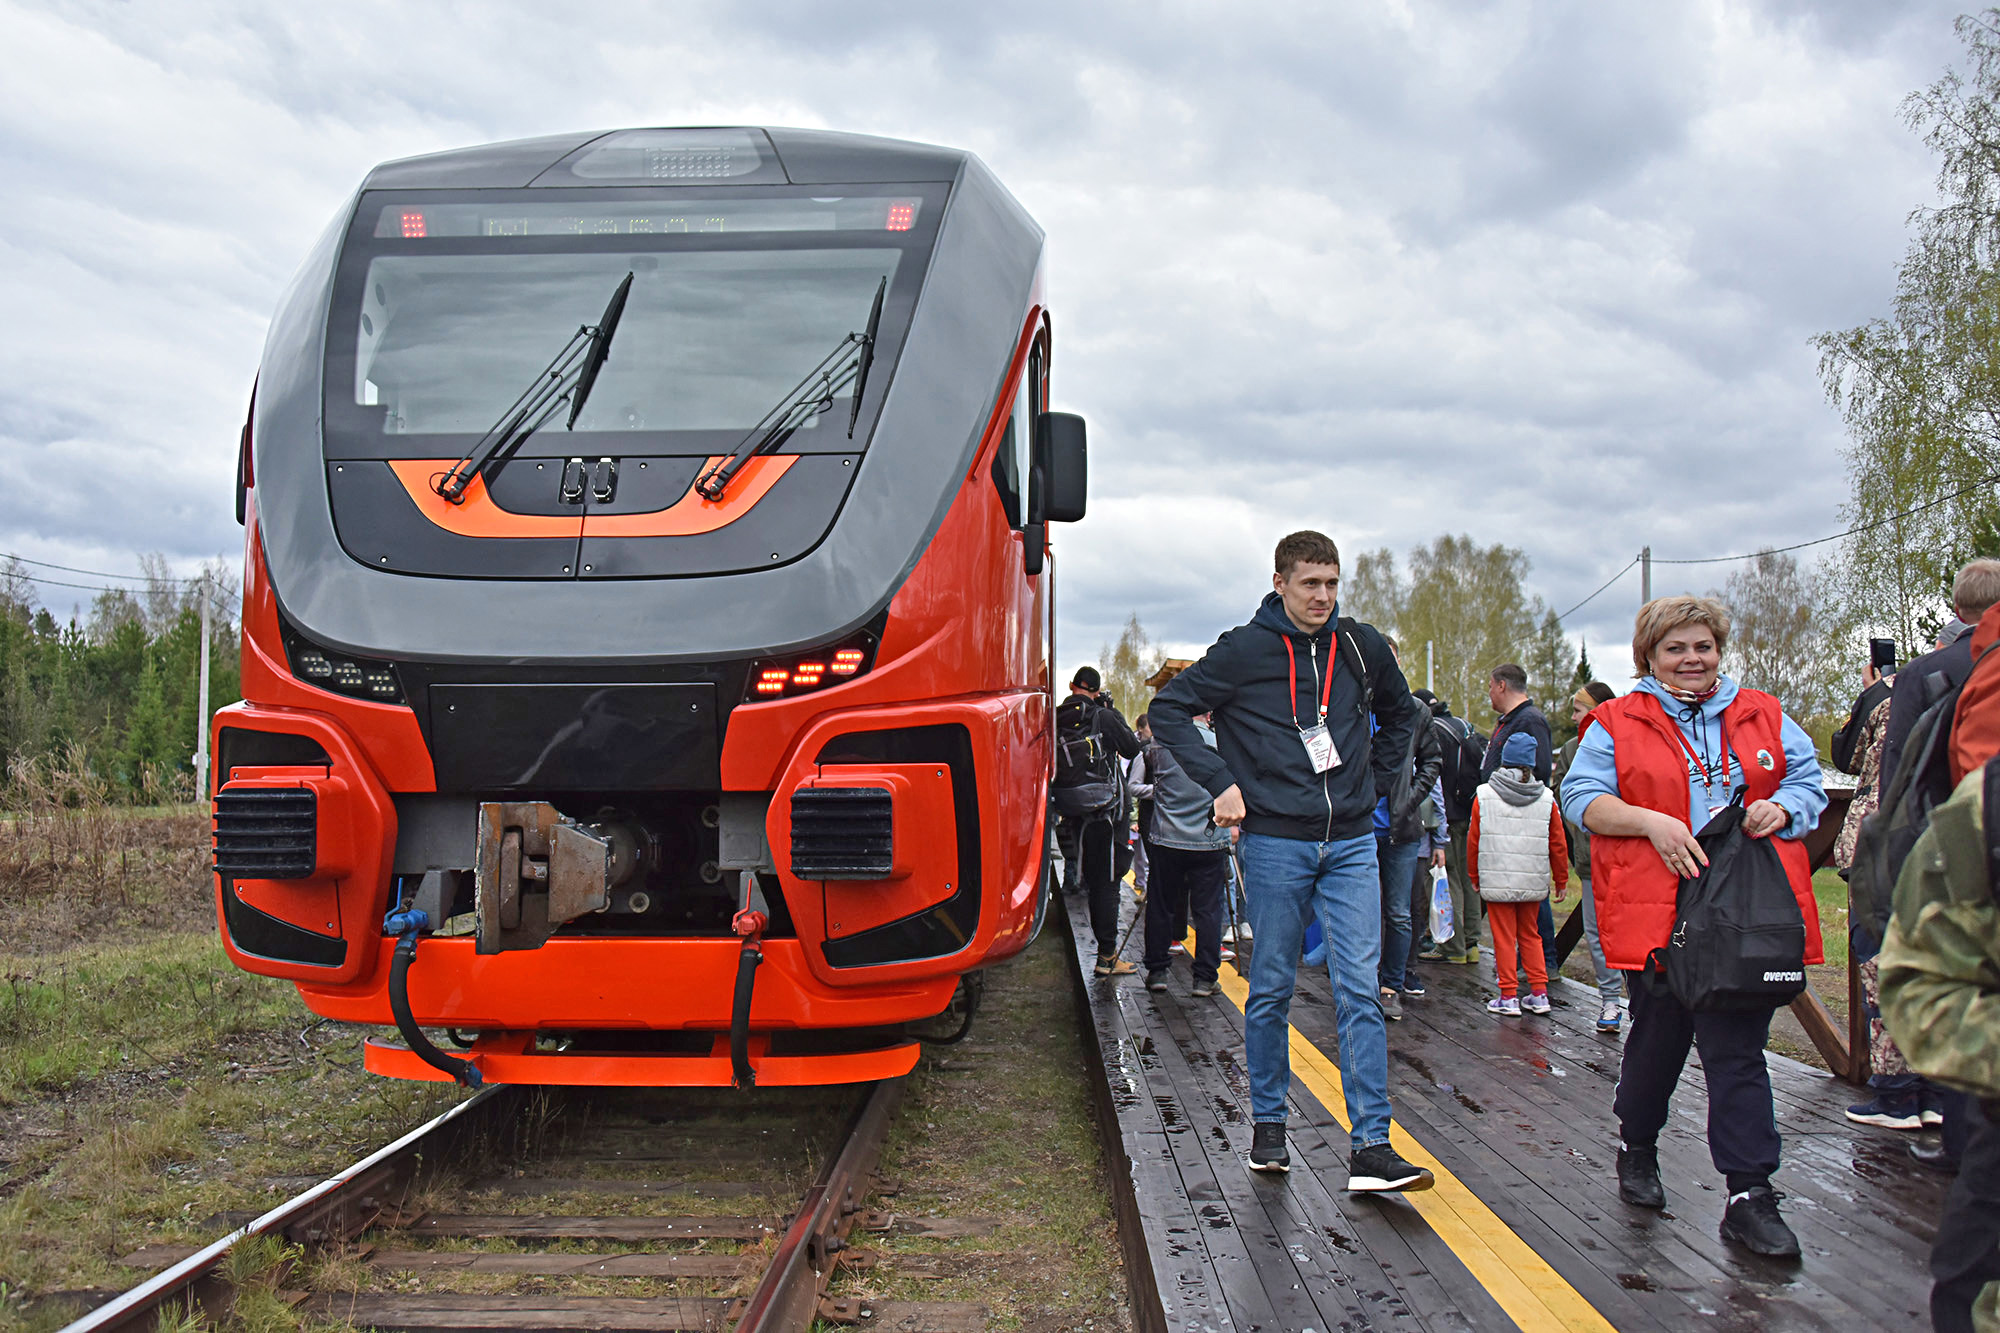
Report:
326,186,942,456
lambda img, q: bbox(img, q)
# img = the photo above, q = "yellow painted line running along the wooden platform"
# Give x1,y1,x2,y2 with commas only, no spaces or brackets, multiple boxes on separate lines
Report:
1188,935,1616,1333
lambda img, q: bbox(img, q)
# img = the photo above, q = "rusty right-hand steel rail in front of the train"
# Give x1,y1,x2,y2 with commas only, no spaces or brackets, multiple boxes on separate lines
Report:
736,1079,904,1333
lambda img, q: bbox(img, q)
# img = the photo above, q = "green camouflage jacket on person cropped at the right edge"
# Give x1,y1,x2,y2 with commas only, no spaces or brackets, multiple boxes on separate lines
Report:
1880,759,2000,1099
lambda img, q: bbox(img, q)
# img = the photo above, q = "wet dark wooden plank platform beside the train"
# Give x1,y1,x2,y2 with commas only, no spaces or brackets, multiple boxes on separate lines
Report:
1052,880,1944,1333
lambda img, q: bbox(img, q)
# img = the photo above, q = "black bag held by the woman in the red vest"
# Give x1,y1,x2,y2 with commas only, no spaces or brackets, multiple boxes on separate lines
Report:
1648,789,1806,1013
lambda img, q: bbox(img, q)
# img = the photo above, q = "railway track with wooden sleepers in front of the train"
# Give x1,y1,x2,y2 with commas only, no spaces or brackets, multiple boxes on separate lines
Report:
64,1079,986,1333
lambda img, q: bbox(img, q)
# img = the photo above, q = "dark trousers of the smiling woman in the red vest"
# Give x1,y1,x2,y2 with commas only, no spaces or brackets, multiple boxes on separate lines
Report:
1612,973,1780,1193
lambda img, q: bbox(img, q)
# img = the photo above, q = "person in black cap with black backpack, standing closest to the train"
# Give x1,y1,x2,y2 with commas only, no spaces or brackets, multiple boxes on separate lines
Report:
1048,667,1138,977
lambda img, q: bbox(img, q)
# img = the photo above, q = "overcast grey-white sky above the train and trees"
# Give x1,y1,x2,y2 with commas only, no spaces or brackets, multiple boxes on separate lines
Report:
0,0,1962,703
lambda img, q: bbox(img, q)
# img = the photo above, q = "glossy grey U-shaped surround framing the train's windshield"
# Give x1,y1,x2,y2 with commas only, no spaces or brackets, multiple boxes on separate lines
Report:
252,130,1042,664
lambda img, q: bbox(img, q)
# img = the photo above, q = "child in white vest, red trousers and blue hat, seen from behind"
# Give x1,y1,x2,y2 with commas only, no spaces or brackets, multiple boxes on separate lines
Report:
1466,733,1570,1017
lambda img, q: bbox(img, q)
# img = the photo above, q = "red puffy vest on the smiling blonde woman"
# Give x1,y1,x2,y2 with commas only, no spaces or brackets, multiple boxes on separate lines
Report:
1590,689,1826,971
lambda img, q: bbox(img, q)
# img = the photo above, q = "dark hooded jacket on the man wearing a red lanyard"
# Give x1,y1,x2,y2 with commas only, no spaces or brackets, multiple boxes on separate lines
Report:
1146,592,1418,843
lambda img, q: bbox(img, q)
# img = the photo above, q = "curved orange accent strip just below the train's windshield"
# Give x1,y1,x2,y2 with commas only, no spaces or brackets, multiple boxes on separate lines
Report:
388,454,798,538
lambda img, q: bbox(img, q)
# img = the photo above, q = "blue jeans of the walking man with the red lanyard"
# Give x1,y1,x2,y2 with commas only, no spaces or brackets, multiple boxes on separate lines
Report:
1238,833,1410,1149
